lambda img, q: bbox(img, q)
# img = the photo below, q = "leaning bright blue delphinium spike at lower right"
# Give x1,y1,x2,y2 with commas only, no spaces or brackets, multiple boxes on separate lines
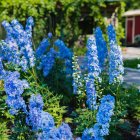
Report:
93,95,115,138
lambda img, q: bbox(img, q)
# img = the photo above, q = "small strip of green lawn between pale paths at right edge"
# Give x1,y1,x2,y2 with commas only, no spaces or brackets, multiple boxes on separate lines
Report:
124,58,140,69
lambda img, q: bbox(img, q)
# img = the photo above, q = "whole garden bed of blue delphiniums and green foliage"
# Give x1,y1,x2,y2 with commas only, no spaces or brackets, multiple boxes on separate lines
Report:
0,17,140,140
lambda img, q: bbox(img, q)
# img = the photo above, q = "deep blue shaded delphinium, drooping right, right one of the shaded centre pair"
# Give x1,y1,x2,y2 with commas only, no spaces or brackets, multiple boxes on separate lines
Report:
54,39,72,74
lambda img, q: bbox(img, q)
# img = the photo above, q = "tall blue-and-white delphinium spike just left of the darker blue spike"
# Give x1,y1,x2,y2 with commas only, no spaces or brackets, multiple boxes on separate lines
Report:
86,36,101,110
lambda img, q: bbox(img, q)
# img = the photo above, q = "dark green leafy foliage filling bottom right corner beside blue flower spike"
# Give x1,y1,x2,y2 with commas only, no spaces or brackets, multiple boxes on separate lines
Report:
107,86,140,140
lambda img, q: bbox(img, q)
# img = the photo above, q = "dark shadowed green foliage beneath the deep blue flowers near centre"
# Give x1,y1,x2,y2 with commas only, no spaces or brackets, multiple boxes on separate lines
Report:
44,60,72,100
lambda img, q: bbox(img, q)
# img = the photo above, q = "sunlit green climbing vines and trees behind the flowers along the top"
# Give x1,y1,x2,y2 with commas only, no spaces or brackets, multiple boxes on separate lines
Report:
0,0,125,55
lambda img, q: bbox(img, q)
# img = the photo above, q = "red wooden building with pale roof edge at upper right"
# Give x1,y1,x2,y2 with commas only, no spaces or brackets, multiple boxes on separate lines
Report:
124,9,140,44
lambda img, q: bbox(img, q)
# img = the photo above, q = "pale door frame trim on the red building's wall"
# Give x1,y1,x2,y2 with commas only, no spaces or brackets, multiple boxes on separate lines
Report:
126,17,135,43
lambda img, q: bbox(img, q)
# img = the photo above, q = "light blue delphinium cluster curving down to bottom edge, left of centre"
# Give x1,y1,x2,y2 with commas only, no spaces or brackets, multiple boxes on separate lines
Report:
26,94,73,140
